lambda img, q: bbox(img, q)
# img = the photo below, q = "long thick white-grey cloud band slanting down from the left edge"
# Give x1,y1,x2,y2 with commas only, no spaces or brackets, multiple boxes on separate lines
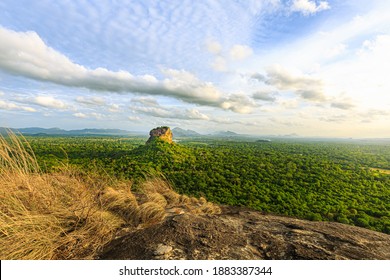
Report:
0,27,253,112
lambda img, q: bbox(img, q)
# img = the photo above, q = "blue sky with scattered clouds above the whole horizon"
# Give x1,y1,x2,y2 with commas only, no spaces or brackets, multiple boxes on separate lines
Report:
0,0,390,138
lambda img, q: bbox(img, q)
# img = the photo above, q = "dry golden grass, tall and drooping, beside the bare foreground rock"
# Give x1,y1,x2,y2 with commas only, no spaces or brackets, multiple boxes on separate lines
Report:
0,133,220,260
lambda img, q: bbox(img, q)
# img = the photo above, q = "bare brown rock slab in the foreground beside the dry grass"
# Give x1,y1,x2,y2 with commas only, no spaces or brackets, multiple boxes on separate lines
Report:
99,207,390,260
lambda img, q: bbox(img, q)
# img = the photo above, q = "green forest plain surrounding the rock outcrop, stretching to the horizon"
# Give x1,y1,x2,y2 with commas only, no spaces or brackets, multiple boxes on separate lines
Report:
28,137,390,233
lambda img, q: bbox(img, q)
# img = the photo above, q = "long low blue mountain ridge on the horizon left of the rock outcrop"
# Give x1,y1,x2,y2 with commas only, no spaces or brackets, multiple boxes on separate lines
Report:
0,127,137,136
